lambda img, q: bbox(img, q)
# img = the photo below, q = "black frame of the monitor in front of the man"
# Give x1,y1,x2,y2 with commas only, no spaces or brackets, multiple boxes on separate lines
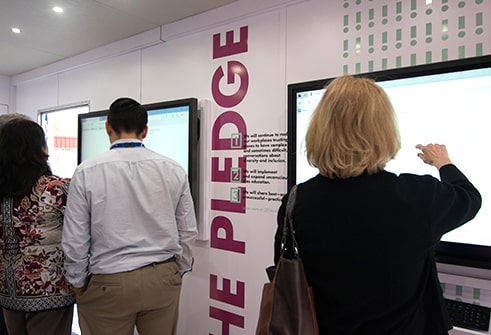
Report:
77,98,200,207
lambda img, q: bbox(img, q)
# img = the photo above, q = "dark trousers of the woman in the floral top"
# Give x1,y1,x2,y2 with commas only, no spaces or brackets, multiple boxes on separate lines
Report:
3,306,73,335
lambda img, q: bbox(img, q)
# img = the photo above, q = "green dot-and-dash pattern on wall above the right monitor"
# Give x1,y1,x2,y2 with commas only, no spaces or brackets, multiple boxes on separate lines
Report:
342,0,491,74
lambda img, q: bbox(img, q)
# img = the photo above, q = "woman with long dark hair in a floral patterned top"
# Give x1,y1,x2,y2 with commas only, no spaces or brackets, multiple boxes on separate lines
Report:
0,118,75,335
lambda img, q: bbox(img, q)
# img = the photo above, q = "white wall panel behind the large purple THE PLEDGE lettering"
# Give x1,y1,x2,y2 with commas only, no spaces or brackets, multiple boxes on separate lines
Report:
148,10,286,334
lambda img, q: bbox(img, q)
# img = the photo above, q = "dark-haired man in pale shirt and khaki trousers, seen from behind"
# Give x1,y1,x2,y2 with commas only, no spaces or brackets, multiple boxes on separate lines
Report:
62,98,197,335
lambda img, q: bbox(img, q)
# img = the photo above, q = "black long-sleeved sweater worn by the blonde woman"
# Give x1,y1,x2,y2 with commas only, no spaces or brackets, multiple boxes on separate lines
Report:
275,165,481,335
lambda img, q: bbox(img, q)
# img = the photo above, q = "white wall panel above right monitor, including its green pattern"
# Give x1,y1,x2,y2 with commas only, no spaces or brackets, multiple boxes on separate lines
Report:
287,0,491,83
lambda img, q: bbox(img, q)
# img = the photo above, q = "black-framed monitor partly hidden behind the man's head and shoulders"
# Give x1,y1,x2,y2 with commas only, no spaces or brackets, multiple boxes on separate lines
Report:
78,98,199,205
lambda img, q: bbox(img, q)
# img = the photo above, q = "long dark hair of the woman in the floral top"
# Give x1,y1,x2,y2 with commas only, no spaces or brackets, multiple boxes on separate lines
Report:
0,118,52,196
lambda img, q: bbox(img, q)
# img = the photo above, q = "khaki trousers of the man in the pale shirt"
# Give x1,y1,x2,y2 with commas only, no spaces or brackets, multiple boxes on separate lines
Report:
77,261,182,335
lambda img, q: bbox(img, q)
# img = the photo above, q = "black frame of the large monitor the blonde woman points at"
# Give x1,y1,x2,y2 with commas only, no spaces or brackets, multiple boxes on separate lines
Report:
287,55,491,270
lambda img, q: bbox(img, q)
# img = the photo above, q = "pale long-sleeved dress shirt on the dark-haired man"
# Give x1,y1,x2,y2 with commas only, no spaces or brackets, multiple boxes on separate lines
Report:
62,139,197,287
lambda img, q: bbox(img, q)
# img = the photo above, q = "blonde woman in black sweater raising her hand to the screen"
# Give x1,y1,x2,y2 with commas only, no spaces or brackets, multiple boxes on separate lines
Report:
275,76,481,335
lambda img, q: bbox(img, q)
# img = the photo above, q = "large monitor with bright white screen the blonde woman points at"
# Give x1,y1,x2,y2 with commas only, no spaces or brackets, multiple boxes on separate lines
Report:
288,56,491,269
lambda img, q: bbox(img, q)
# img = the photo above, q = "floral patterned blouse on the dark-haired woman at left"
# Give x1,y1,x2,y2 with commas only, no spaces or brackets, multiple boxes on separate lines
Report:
0,176,75,312
